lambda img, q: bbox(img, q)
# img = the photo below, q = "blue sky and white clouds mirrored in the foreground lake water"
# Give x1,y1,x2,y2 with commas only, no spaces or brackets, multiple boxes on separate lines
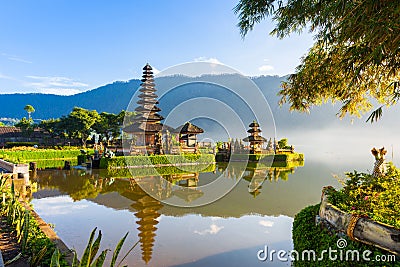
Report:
32,196,293,266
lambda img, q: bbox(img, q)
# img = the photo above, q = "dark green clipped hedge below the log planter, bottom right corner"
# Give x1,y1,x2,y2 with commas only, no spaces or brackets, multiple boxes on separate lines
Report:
293,204,400,267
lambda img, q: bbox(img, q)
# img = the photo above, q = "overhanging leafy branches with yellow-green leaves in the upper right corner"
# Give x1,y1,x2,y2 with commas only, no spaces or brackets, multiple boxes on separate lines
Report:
234,0,400,122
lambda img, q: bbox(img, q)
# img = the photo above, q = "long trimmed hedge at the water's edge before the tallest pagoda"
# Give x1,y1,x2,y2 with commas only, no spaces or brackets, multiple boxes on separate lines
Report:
100,154,215,169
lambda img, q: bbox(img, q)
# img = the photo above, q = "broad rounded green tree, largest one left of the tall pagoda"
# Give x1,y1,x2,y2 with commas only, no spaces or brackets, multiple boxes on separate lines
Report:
65,107,100,147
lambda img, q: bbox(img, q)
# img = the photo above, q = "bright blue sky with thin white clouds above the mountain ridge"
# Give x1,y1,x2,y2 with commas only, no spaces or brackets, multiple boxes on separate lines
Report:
0,0,312,94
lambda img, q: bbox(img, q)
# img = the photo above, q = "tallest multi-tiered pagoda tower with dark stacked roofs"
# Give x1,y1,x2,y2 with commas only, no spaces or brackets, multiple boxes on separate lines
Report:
124,63,164,154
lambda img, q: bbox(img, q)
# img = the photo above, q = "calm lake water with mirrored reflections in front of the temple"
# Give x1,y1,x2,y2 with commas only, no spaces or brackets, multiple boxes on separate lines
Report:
31,139,400,266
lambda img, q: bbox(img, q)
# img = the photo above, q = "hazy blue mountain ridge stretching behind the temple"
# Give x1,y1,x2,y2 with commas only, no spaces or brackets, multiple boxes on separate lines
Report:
0,74,397,136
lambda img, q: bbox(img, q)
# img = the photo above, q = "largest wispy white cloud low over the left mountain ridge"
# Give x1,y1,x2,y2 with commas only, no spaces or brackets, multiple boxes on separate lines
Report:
25,75,89,95
